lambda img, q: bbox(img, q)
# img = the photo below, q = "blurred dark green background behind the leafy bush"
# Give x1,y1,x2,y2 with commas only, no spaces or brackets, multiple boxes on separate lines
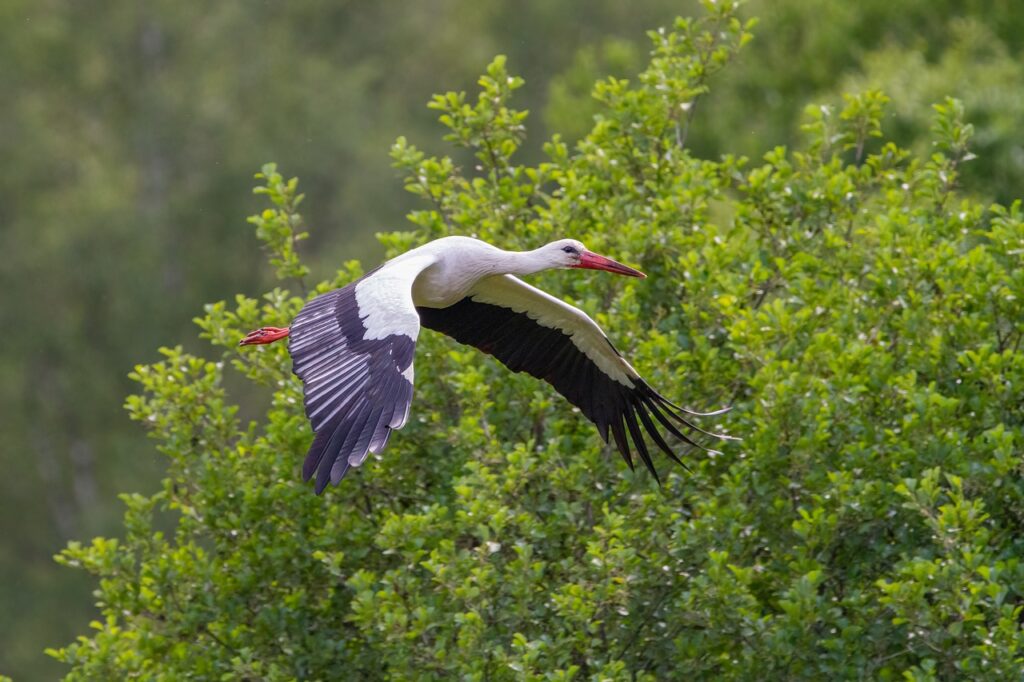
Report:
6,0,1024,679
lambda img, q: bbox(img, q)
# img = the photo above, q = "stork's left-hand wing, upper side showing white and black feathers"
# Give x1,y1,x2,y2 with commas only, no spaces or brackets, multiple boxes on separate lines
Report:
288,257,433,495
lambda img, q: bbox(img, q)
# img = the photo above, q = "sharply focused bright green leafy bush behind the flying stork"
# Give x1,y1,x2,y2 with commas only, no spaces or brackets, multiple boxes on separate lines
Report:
53,3,1024,680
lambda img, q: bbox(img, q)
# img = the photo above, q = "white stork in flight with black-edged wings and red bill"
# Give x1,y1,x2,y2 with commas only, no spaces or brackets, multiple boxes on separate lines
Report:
240,237,729,495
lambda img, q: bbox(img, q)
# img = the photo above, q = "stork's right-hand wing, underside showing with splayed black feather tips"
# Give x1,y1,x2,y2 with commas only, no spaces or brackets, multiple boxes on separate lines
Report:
417,274,727,480
